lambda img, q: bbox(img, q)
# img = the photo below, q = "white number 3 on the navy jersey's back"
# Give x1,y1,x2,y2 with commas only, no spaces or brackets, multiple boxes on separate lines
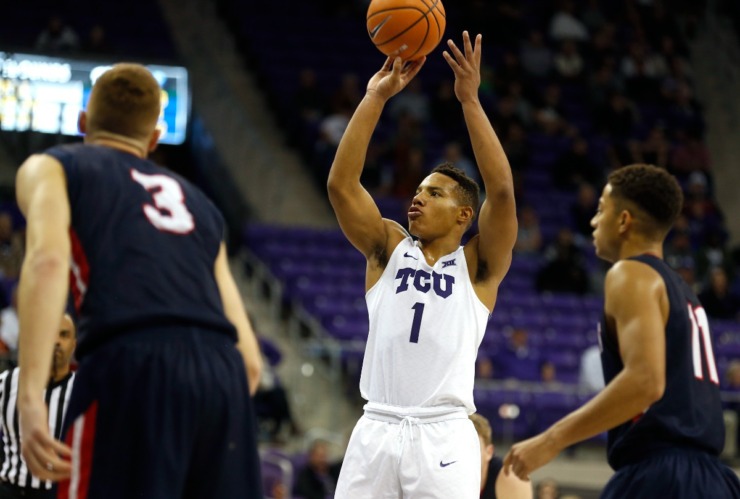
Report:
131,170,195,234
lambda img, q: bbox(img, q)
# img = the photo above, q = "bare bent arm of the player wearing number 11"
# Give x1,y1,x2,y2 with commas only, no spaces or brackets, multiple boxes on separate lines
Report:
504,260,668,479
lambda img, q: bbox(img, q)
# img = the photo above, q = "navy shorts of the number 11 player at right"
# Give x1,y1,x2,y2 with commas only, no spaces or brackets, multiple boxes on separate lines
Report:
601,448,740,499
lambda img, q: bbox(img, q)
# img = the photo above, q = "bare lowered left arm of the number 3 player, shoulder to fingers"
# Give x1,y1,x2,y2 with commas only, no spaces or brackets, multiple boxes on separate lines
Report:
16,155,70,480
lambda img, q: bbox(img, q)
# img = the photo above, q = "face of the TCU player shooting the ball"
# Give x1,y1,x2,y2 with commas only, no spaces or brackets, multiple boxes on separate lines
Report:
408,173,460,238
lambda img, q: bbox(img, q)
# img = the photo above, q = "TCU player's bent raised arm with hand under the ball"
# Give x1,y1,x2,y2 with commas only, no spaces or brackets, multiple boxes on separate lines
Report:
327,57,425,257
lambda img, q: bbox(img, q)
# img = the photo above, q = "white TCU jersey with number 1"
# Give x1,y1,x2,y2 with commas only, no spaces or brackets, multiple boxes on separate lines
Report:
360,237,489,413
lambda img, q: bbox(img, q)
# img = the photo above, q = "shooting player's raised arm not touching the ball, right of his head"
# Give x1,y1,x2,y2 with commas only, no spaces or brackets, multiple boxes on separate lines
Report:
443,31,517,299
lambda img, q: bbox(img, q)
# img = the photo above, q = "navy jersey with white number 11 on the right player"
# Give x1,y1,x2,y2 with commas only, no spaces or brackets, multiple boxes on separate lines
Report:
601,255,725,469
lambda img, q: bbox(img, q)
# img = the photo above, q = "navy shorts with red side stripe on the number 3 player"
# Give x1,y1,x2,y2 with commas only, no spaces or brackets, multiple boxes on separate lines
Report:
59,328,263,499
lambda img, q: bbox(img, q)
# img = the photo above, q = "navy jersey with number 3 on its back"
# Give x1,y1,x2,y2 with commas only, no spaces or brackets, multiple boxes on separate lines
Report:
46,144,236,359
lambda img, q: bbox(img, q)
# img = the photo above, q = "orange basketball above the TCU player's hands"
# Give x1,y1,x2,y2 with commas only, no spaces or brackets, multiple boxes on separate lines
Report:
367,0,447,61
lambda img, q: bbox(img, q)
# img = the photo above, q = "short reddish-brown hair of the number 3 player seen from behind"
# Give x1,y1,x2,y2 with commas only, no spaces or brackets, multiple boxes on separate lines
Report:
87,63,161,140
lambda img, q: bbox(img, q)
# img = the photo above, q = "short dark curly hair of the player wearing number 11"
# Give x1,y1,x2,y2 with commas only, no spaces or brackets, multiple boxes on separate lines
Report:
607,164,683,236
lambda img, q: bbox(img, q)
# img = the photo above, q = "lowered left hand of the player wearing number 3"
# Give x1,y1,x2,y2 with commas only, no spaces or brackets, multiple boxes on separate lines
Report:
18,398,72,482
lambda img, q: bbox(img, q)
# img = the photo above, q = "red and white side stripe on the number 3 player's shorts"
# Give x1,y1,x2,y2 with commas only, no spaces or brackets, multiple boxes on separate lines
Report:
57,401,98,499
